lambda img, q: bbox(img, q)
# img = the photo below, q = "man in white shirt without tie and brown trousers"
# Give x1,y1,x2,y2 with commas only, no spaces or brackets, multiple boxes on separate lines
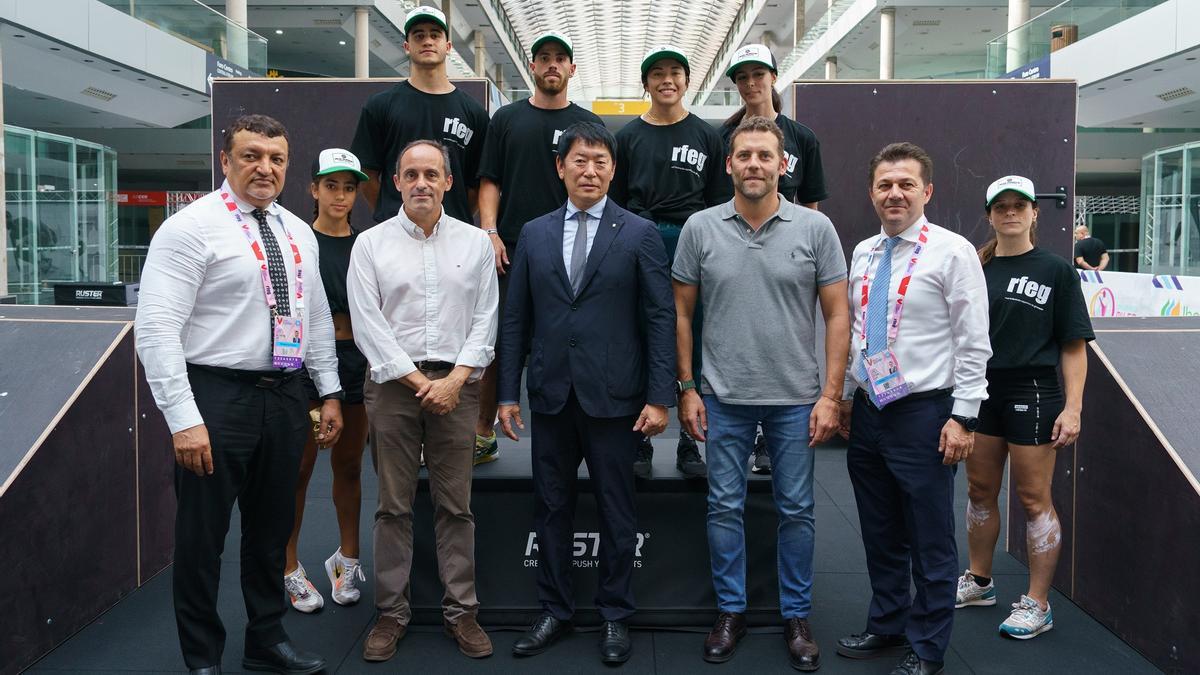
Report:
347,141,499,661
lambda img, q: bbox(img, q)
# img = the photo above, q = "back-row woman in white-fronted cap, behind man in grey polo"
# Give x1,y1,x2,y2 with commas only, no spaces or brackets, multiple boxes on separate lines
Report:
720,44,829,209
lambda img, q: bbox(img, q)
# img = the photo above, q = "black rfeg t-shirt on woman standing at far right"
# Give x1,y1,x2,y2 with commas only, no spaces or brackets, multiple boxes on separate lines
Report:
983,247,1096,370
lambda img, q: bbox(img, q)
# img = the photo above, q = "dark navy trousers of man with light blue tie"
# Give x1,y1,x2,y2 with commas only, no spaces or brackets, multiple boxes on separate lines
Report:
846,390,959,662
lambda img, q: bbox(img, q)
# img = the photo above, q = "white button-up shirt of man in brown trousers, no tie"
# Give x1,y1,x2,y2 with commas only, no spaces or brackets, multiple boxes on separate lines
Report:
347,209,500,383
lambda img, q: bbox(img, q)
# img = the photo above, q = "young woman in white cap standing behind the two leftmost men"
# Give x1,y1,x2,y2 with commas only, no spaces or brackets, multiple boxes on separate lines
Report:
283,148,367,614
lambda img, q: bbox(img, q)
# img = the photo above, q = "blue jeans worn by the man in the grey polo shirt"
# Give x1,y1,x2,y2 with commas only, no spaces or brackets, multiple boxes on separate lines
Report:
704,395,816,619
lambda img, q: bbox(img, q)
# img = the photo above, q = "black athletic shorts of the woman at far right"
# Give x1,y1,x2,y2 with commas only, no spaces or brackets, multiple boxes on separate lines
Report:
978,368,1063,446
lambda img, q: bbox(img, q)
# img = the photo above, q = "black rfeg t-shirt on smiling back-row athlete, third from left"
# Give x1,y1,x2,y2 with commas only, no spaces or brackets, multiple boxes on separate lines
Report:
608,113,733,225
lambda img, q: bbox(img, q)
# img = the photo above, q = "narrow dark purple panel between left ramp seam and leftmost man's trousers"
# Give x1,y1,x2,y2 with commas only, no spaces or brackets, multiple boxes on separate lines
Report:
134,362,175,584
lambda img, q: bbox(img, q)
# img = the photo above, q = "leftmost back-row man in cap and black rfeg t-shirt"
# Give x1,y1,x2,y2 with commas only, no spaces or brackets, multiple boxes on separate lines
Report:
350,7,487,222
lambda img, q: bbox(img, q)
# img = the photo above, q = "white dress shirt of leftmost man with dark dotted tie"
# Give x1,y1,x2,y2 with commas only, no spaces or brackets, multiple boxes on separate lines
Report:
134,181,342,434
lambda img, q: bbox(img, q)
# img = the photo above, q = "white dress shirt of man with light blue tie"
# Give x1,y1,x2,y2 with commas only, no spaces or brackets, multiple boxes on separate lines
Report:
846,216,991,417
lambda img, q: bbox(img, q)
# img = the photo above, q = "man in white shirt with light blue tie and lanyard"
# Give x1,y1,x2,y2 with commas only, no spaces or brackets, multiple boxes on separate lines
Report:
838,143,991,675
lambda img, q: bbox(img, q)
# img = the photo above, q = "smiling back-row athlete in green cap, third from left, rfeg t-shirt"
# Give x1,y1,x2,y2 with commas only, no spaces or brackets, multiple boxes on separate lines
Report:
608,44,733,478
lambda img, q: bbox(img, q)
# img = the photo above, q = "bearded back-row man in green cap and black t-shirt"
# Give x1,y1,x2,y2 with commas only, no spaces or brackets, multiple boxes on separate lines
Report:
474,32,602,465
